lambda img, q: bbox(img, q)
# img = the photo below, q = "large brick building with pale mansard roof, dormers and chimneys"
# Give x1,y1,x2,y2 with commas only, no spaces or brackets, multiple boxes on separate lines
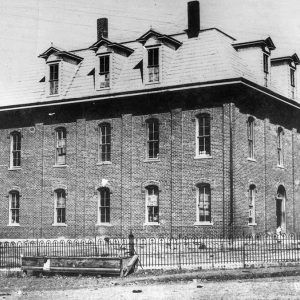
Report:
0,1,300,238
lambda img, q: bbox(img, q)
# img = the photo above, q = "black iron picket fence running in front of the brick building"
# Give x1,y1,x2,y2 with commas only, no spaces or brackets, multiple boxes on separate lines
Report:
0,234,300,268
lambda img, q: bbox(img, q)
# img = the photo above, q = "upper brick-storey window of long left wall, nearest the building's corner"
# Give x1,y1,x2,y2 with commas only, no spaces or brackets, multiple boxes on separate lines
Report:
196,114,211,156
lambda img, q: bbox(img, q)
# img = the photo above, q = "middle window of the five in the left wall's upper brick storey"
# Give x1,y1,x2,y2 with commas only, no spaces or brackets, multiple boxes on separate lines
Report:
98,123,111,162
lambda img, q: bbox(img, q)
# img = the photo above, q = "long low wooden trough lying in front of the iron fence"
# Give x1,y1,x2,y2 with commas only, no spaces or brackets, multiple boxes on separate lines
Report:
21,256,137,276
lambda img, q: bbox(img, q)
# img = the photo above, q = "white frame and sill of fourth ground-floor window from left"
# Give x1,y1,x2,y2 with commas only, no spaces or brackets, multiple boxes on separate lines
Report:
145,184,160,225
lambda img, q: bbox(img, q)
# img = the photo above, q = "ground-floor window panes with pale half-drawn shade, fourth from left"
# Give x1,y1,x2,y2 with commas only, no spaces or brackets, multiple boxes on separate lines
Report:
146,185,159,223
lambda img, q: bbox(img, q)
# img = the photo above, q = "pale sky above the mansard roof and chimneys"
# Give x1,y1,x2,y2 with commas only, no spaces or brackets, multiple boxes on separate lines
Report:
0,0,300,93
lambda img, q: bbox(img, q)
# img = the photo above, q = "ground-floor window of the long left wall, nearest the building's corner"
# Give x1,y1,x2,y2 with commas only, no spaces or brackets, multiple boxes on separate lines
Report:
197,184,211,223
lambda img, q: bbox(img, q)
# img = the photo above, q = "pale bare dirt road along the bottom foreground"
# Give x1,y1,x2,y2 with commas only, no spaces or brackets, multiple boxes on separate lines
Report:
0,276,300,300
